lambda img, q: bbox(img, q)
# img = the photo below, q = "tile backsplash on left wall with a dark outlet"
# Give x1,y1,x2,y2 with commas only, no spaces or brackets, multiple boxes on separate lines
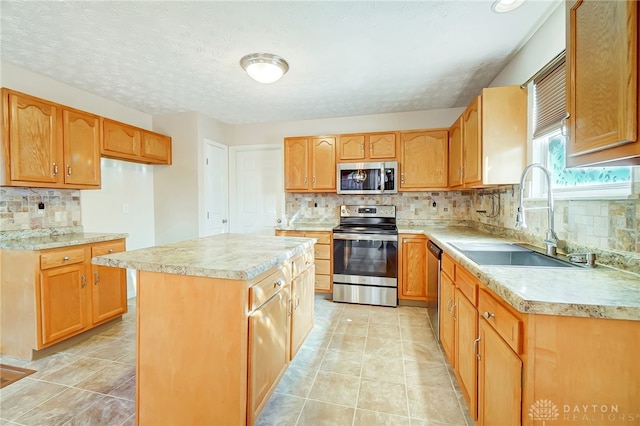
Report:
0,187,82,239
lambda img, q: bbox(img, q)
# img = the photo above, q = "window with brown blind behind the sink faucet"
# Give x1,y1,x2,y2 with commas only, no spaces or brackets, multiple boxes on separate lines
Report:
531,54,632,199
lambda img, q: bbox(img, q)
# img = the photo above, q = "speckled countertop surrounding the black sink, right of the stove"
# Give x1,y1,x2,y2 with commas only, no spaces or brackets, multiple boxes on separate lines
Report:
412,227,640,321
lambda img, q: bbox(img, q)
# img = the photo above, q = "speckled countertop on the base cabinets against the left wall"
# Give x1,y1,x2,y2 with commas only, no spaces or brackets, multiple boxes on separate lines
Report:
0,232,129,250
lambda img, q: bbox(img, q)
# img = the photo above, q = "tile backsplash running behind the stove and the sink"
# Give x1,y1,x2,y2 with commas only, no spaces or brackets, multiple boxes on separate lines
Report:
286,180,640,254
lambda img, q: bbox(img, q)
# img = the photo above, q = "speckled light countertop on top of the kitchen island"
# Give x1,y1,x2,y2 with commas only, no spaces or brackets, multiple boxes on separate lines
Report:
91,234,316,280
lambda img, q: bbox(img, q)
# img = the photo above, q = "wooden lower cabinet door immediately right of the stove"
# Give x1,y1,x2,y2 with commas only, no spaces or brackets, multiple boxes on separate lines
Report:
398,234,428,302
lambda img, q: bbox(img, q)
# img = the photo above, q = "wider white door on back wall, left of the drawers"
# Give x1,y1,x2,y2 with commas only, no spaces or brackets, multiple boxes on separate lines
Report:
229,145,284,235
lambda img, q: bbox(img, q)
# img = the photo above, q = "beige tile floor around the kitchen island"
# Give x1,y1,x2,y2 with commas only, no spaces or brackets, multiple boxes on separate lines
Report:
0,295,474,426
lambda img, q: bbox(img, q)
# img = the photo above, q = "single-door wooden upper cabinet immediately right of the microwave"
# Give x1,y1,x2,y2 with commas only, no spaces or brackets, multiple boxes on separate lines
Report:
399,129,449,191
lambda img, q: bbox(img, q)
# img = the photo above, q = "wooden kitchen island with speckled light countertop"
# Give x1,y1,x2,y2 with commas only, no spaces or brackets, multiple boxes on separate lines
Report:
92,234,315,425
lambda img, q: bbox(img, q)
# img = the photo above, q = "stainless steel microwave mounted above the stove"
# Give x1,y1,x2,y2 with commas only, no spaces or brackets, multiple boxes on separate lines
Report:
337,161,398,194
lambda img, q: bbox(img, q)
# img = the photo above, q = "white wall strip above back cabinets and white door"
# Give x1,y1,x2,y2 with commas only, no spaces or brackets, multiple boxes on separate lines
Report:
231,108,464,145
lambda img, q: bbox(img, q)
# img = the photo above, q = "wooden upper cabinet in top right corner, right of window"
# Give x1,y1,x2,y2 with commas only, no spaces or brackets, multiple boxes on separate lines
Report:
566,0,640,166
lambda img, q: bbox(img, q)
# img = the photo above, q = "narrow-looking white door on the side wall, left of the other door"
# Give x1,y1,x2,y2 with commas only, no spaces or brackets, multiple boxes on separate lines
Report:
200,139,229,237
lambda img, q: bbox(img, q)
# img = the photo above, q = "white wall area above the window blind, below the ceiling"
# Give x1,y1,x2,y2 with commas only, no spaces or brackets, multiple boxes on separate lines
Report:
490,2,566,87
